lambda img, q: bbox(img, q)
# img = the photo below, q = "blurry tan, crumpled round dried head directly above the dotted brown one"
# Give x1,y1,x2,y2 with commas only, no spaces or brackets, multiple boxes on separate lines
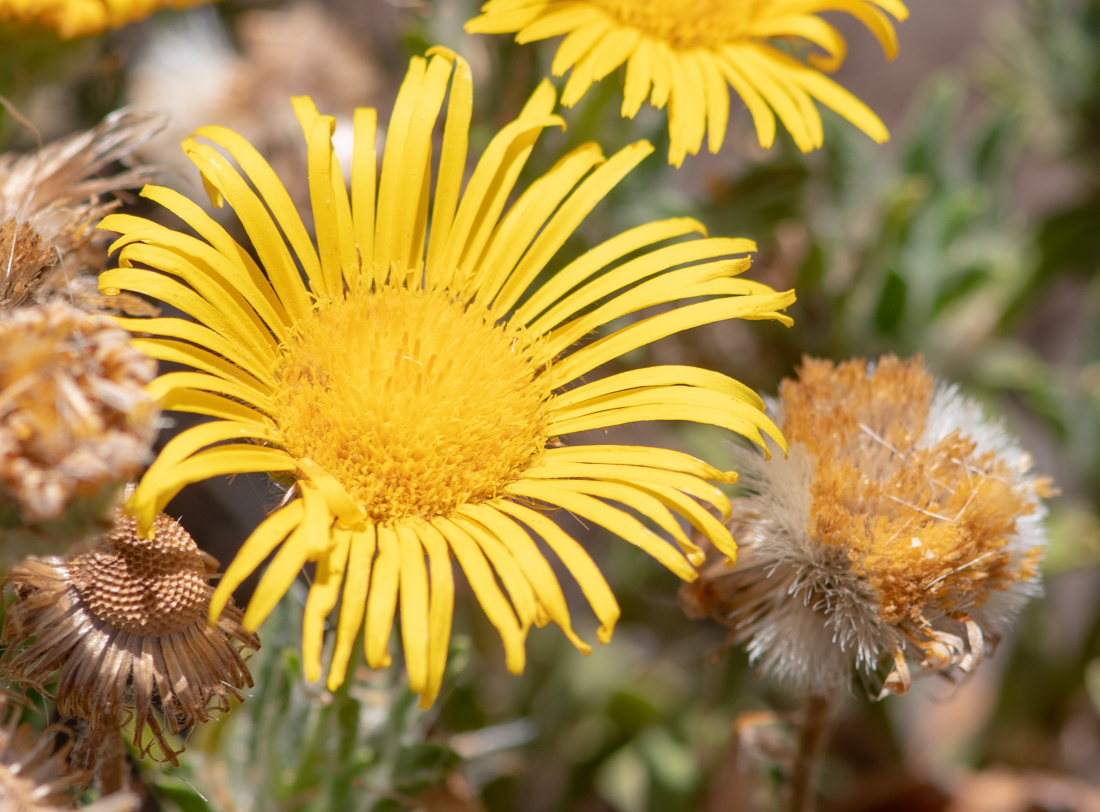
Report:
0,301,157,563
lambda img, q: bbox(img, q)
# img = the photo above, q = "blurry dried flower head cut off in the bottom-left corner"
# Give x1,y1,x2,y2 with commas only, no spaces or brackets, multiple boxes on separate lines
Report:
0,694,139,812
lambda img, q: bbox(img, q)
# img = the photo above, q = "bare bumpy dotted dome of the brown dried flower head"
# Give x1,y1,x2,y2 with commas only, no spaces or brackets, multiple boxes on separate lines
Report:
69,514,209,637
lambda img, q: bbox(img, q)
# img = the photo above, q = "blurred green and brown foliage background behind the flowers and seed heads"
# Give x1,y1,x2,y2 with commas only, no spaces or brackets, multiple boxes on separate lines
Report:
0,0,1100,812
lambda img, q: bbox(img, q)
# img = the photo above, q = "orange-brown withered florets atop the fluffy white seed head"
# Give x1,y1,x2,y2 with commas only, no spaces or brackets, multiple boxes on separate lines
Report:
781,358,1037,625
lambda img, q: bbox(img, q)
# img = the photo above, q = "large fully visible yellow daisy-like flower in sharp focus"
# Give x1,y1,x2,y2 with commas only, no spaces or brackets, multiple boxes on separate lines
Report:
100,50,794,705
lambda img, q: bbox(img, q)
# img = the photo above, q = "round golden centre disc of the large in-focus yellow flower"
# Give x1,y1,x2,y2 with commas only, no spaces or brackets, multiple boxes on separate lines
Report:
276,285,550,522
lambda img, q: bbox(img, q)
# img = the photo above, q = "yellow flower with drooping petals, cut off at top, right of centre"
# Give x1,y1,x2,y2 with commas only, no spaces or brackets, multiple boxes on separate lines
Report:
466,0,909,166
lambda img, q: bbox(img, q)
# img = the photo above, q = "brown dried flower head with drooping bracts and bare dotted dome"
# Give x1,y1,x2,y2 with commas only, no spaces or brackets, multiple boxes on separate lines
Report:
2,514,260,764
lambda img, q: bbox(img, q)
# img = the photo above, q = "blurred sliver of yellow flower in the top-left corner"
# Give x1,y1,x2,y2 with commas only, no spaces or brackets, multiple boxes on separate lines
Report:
0,0,209,40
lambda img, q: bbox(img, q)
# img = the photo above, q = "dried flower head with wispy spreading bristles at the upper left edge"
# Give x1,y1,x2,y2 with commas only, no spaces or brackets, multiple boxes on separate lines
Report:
0,109,165,315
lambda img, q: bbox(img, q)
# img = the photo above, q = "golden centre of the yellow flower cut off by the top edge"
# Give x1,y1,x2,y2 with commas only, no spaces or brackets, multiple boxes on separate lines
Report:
590,0,763,48
